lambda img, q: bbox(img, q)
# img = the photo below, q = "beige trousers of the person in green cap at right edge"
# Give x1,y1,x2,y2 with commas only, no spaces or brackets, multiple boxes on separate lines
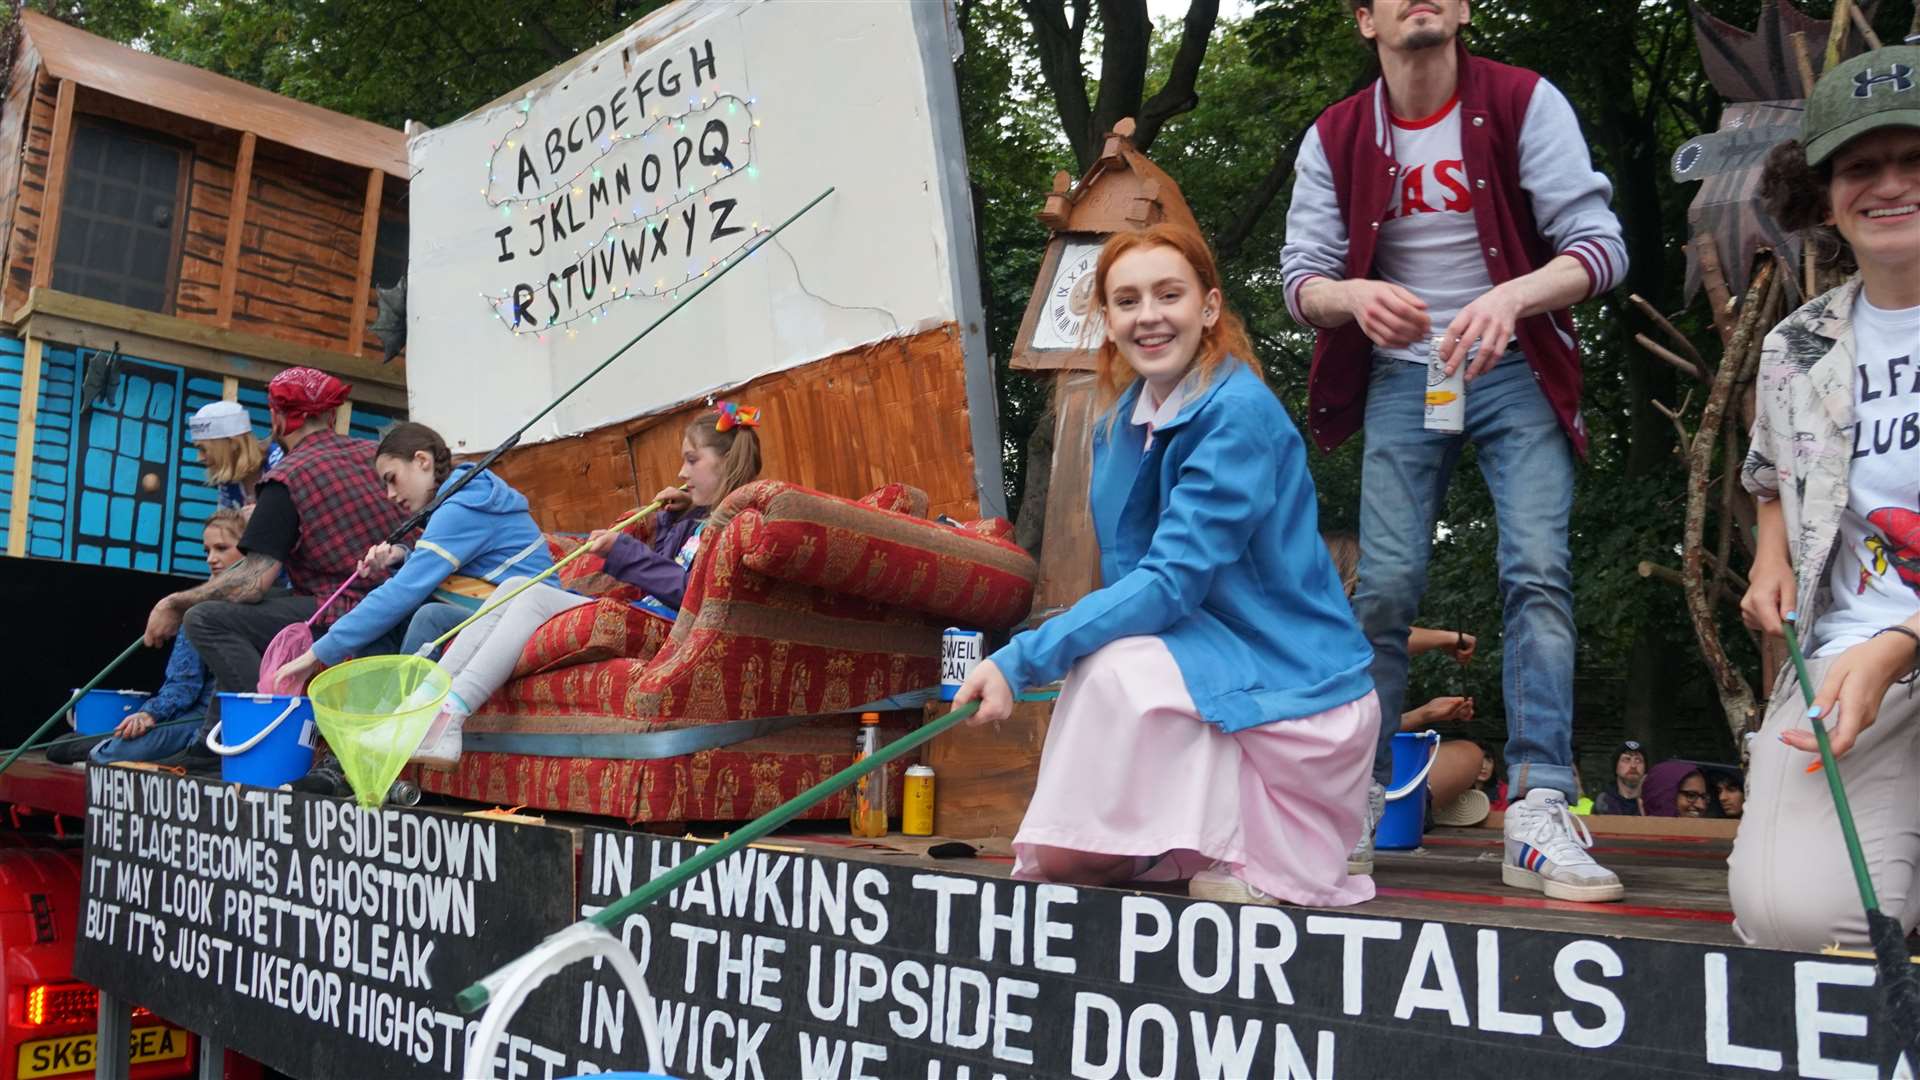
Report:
1726,641,1920,949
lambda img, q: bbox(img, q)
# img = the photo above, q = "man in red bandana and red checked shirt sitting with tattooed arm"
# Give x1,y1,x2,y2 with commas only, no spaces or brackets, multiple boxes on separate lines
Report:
146,367,405,709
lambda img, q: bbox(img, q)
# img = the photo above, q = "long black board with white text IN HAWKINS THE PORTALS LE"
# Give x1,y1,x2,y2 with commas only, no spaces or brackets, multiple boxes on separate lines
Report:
515,830,1912,1080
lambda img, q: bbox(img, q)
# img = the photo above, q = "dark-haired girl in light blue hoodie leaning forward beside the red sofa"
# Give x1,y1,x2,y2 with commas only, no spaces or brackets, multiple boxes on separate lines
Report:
264,423,553,686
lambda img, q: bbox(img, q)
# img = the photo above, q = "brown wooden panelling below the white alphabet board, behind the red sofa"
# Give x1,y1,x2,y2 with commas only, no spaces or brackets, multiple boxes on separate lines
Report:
487,325,979,532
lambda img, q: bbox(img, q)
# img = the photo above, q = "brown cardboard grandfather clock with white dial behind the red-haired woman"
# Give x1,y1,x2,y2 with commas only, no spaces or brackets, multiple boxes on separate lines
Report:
927,119,1200,838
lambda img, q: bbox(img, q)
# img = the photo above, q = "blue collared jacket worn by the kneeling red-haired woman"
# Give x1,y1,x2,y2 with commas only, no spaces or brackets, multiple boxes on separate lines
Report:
989,359,1373,732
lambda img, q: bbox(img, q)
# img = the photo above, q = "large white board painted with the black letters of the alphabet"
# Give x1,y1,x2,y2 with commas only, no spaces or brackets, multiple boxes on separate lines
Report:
407,0,975,455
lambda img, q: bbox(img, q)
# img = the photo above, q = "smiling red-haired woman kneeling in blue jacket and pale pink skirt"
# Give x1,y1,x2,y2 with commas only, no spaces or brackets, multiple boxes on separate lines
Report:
956,225,1379,905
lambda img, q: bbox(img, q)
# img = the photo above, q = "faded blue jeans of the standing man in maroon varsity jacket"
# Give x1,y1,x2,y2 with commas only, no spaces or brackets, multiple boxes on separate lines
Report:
1354,352,1574,801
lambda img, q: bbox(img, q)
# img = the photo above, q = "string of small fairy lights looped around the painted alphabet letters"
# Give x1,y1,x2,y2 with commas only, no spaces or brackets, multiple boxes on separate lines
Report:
480,90,766,342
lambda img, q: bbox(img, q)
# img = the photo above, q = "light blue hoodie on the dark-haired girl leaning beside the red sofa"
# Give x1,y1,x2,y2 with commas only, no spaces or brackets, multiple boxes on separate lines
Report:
313,465,553,667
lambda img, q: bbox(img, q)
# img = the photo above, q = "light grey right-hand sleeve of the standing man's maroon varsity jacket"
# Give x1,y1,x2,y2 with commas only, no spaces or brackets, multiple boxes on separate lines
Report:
1520,79,1626,296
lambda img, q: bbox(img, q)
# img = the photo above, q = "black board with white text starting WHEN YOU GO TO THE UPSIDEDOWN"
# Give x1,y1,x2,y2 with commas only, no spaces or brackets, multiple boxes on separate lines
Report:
73,767,574,1076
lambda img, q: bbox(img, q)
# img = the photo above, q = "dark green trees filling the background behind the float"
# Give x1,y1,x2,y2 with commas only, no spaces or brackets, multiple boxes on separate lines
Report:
42,0,1866,772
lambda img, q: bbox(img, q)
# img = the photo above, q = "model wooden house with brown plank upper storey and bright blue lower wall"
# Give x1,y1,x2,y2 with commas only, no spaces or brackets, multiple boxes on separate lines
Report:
0,12,407,573
